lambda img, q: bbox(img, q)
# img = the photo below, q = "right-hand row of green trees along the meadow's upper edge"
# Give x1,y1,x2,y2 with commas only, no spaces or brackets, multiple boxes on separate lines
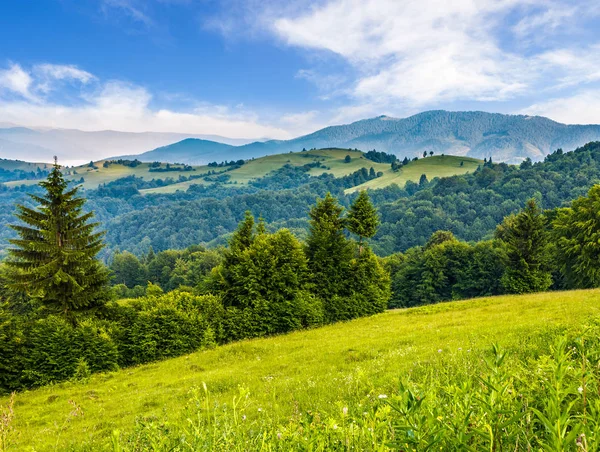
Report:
384,185,600,307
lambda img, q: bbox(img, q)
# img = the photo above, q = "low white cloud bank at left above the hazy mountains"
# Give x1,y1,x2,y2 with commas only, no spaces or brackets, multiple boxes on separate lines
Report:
0,64,290,138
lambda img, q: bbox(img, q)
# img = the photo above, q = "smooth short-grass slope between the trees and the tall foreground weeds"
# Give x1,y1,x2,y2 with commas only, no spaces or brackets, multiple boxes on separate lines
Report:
0,290,600,451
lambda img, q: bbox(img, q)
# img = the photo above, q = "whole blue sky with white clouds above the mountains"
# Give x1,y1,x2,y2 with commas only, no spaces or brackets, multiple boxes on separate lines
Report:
0,0,600,139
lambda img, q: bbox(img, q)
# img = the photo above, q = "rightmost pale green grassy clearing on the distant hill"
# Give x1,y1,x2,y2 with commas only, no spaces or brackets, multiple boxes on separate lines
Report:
346,155,483,193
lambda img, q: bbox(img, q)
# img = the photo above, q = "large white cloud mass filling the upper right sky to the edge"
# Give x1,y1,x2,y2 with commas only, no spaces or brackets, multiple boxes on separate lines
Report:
271,0,600,110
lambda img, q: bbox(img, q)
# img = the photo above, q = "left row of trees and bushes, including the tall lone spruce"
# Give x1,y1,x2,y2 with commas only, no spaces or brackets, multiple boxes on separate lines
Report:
0,164,390,390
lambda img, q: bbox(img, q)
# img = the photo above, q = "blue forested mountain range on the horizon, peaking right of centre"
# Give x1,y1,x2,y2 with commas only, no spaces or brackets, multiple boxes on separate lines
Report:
125,110,600,165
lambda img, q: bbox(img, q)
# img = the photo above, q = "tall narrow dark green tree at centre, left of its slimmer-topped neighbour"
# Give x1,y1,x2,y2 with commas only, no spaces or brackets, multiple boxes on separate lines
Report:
306,193,354,303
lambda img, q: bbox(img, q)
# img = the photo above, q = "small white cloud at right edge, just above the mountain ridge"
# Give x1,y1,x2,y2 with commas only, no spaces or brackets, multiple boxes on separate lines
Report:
521,89,600,124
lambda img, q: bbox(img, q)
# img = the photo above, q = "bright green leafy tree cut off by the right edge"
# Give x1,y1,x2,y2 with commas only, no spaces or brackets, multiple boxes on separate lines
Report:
552,185,600,288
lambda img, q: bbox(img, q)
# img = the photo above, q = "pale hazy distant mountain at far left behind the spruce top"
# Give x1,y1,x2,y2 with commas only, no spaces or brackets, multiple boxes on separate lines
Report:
0,124,255,165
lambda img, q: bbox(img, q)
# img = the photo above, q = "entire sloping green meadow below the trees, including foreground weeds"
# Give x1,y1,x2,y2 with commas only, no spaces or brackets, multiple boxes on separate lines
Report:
0,290,600,452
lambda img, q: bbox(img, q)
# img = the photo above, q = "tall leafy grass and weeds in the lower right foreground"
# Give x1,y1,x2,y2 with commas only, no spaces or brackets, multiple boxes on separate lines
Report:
112,325,600,452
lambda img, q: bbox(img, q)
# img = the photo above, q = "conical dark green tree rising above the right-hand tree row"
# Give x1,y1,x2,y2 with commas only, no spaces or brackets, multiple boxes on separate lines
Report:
496,199,552,293
